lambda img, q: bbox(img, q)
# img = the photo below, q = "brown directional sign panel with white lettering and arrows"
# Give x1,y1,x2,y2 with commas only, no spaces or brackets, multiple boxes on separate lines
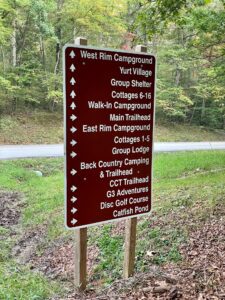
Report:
64,45,155,228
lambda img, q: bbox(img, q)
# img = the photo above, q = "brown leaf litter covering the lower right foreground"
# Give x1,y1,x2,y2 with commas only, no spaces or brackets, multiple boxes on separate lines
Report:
51,217,225,300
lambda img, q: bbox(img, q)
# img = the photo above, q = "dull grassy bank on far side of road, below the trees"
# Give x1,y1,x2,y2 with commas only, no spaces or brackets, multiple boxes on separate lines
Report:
0,111,225,144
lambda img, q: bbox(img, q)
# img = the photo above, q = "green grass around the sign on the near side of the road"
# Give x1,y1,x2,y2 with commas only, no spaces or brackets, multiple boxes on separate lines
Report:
0,151,225,300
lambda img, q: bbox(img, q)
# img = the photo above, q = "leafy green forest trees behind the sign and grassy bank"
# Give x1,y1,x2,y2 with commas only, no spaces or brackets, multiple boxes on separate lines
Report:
0,0,225,129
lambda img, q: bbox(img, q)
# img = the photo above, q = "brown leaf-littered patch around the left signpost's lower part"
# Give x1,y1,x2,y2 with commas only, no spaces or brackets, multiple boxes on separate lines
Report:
31,240,99,281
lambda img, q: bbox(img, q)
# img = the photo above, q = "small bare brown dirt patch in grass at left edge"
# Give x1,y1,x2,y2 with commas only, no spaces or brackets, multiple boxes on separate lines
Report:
0,191,23,228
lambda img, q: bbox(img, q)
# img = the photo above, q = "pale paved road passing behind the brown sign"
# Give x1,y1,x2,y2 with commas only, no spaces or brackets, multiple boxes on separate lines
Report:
0,142,225,160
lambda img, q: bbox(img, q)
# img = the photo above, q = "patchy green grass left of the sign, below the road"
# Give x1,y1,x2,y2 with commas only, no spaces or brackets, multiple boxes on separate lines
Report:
0,160,64,300
